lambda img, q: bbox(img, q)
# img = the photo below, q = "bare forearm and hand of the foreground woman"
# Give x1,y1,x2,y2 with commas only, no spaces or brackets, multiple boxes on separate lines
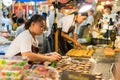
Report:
22,52,61,62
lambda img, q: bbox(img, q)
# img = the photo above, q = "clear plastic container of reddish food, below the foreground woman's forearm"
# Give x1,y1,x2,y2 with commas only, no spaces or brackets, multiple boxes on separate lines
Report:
27,65,59,80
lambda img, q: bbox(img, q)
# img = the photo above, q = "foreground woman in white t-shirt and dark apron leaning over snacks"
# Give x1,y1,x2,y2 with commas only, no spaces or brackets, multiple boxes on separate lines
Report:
5,14,61,62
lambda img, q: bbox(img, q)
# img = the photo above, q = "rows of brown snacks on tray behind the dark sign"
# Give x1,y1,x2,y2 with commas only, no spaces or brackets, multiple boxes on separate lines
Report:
56,59,92,74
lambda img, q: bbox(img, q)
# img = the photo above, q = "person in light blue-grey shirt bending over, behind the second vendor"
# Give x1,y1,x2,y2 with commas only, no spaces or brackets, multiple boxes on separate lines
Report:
77,10,95,43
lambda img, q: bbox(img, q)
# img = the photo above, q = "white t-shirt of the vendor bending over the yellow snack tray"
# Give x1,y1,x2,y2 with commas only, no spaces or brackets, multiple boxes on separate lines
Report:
58,14,77,33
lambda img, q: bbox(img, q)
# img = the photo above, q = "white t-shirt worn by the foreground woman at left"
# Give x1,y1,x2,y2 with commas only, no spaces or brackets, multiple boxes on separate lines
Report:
5,30,38,58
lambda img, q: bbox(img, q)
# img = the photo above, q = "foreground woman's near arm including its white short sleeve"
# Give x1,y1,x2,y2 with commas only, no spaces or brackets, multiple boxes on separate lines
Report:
20,37,61,62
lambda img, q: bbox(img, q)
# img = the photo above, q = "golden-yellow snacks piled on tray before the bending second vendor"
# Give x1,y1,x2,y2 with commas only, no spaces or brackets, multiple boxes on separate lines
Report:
66,48,94,57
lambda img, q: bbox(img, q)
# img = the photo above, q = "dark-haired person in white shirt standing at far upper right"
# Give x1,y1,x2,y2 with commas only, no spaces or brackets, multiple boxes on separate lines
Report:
101,5,116,38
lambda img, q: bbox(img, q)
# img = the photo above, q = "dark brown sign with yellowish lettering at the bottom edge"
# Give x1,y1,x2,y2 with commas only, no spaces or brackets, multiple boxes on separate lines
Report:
61,71,95,80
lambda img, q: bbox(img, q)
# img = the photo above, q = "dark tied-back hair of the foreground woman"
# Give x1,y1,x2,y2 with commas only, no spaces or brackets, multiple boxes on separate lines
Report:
25,14,45,29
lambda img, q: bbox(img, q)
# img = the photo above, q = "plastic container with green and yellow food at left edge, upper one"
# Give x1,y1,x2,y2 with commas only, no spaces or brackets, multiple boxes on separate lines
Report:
0,57,30,70
